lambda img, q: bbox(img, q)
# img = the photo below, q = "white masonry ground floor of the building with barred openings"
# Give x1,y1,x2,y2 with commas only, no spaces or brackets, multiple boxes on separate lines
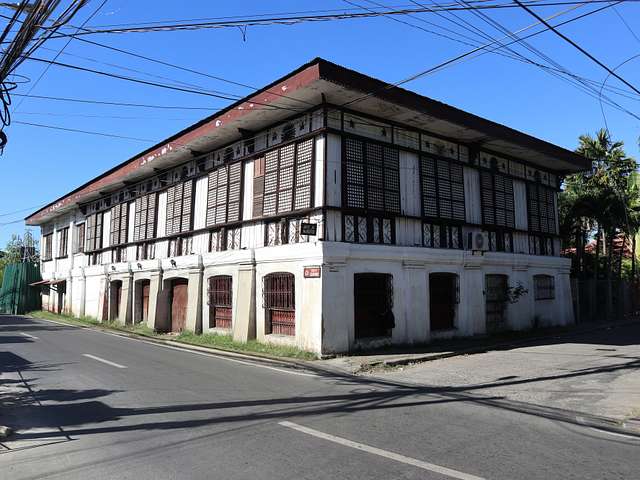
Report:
38,242,574,354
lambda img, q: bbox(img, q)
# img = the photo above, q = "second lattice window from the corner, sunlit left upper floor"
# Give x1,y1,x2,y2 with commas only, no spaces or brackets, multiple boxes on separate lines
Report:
206,162,242,227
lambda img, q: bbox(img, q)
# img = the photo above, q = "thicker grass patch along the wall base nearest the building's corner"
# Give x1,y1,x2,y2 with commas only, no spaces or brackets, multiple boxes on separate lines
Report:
175,332,318,360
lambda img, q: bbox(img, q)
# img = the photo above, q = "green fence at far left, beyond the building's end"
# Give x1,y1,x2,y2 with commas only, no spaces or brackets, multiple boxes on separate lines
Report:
0,263,42,315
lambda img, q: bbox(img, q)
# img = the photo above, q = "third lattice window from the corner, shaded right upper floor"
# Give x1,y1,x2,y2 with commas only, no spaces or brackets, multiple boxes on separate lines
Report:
480,171,515,228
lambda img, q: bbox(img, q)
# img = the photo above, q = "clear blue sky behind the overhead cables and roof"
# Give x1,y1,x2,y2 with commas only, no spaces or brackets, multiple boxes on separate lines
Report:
0,0,640,245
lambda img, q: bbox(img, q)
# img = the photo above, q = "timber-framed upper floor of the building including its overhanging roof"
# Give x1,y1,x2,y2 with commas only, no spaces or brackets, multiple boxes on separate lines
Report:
27,59,589,270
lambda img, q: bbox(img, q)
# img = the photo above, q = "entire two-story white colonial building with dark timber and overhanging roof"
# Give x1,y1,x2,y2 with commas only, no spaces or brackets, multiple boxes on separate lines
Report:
27,59,590,354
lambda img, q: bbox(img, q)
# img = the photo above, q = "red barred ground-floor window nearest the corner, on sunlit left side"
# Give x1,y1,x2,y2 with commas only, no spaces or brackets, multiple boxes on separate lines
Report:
262,272,296,335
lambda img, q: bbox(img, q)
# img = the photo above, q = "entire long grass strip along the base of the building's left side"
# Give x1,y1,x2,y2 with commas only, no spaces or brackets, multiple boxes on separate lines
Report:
29,310,318,360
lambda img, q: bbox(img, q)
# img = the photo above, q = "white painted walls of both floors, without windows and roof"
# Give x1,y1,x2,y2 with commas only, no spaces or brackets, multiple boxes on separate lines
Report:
28,60,584,354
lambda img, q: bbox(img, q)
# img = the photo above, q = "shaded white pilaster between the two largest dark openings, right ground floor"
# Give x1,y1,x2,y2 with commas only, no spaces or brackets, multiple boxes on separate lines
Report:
402,262,431,344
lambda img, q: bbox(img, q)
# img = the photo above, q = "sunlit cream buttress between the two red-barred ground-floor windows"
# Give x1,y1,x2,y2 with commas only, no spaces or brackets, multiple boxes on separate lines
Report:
232,261,256,342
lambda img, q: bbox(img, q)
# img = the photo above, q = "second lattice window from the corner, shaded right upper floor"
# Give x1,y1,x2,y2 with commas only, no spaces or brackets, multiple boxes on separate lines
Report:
420,157,465,221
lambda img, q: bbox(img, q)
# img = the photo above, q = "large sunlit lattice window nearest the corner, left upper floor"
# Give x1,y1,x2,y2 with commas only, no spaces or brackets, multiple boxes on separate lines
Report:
254,139,313,217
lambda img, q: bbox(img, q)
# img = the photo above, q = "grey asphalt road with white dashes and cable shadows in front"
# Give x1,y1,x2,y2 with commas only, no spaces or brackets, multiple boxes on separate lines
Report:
0,316,640,480
